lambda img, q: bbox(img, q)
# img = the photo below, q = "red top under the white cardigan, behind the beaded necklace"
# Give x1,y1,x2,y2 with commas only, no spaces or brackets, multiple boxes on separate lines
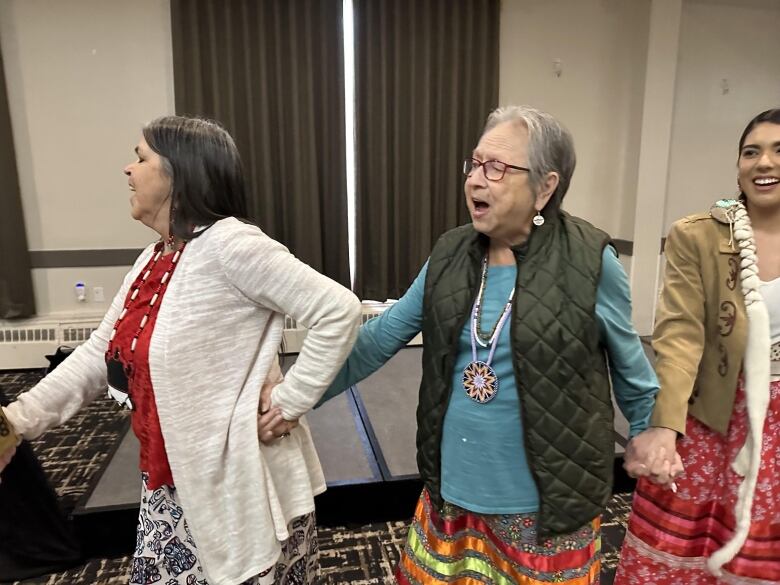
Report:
111,246,174,490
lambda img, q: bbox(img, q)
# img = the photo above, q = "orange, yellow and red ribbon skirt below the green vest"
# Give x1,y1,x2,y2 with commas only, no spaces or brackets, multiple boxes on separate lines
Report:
396,490,601,585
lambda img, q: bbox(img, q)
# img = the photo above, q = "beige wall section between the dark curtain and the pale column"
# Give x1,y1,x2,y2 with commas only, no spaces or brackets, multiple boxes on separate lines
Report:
499,0,650,239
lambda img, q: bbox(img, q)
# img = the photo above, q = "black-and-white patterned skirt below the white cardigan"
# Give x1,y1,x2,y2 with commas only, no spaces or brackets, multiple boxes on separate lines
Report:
129,474,319,585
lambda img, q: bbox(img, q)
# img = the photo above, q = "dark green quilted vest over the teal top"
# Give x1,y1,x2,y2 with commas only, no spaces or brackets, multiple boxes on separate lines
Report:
417,212,614,537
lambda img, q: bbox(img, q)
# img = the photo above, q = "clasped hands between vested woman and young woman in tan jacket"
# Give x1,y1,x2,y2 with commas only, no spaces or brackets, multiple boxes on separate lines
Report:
623,427,685,491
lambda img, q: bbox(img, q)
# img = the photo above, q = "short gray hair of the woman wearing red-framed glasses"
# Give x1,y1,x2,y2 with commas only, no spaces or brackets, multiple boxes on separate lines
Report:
483,106,577,215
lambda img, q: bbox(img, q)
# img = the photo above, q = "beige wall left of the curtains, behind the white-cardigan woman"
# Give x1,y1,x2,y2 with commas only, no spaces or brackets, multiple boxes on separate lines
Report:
0,0,174,315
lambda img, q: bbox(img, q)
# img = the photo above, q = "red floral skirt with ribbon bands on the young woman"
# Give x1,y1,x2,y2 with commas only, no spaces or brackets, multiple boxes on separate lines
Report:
615,381,780,585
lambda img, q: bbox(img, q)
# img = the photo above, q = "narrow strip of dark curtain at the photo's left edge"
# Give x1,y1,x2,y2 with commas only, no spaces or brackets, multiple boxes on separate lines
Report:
0,42,35,319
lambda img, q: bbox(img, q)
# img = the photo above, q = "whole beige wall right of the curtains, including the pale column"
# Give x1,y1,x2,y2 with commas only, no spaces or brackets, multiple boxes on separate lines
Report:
499,0,780,334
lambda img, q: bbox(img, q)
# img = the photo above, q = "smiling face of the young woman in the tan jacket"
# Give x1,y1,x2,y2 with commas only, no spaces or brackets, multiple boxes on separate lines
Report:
737,122,780,209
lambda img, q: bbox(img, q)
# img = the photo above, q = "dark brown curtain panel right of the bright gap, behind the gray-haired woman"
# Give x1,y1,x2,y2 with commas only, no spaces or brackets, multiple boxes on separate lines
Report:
354,0,500,300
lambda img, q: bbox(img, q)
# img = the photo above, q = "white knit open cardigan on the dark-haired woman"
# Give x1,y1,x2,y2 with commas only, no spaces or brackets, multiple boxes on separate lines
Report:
6,218,360,585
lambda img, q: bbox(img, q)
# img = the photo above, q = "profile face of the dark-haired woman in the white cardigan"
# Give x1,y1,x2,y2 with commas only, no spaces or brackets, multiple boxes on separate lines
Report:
124,138,171,229
